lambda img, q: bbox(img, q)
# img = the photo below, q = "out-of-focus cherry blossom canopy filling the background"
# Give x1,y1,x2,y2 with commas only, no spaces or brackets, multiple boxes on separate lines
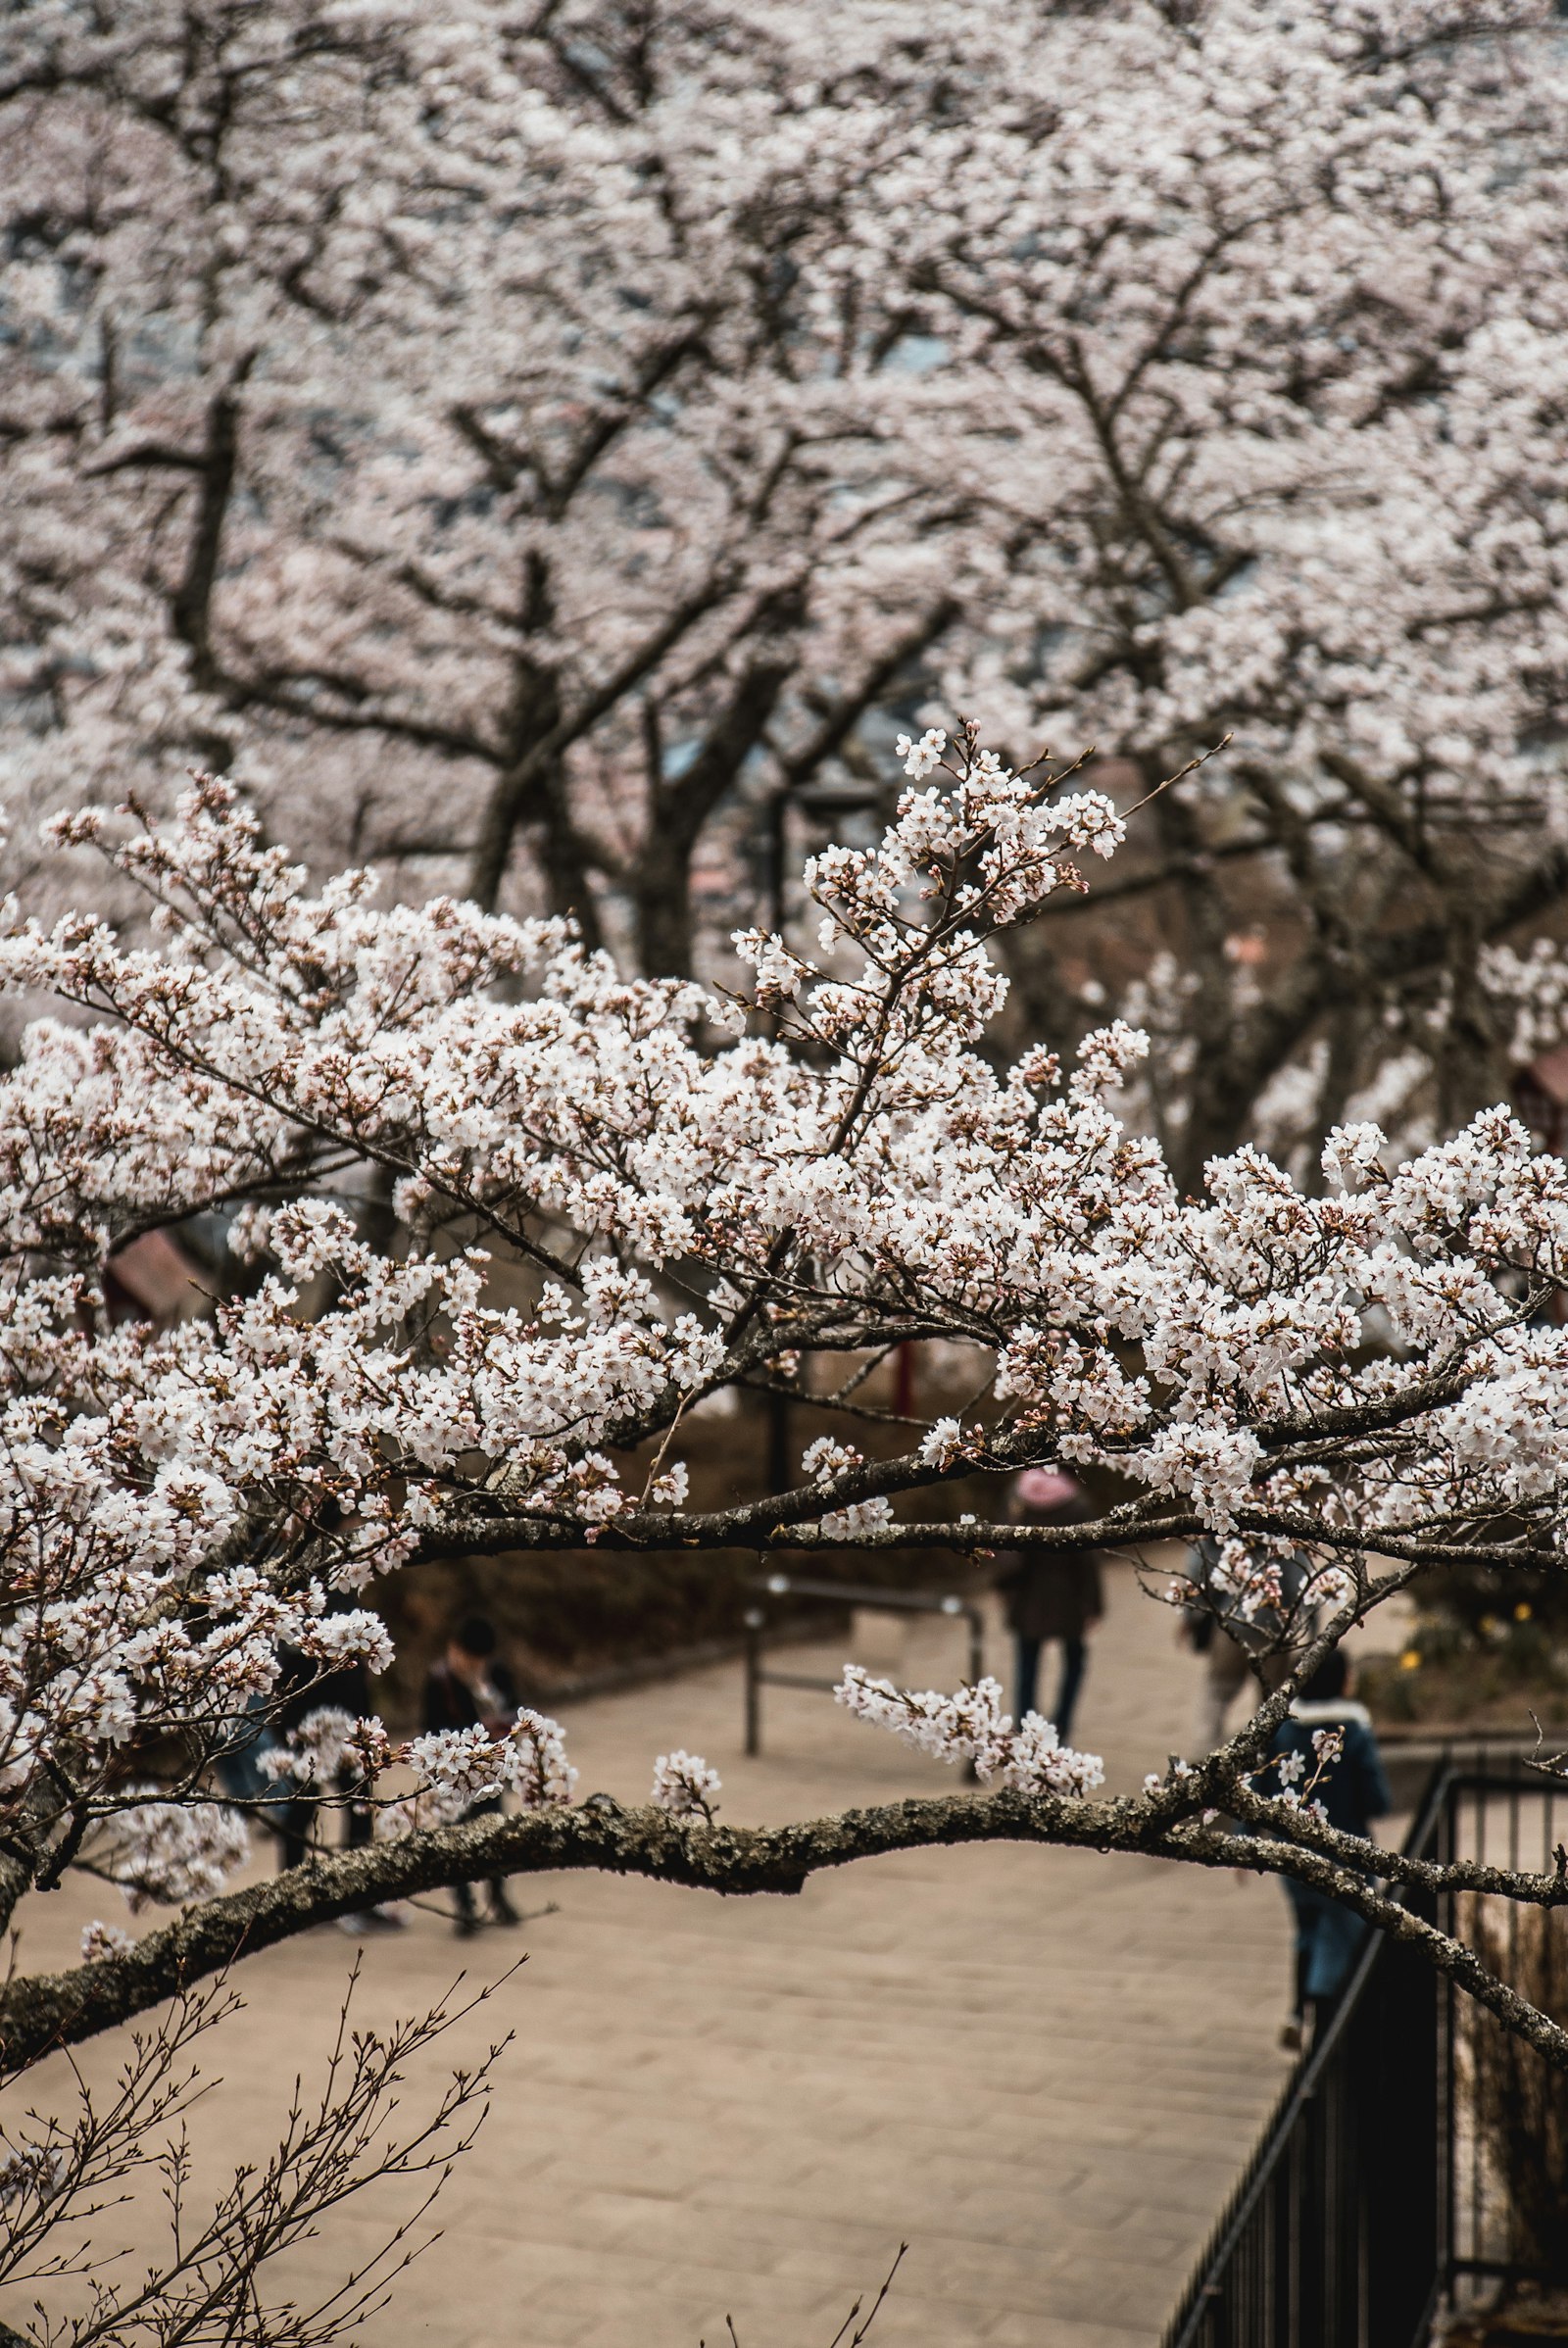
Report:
0,0,1568,1191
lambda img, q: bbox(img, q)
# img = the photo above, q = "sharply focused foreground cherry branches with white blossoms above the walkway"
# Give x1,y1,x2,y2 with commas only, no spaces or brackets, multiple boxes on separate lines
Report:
0,733,1568,2226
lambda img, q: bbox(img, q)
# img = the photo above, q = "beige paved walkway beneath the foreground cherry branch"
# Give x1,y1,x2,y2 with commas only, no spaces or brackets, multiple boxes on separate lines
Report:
12,1571,1287,2348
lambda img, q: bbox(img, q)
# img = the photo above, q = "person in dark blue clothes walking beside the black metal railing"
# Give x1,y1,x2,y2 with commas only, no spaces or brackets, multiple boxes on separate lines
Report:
1258,1646,1390,2047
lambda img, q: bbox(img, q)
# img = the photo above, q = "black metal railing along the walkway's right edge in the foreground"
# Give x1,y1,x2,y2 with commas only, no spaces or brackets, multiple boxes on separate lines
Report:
1164,1754,1563,2348
